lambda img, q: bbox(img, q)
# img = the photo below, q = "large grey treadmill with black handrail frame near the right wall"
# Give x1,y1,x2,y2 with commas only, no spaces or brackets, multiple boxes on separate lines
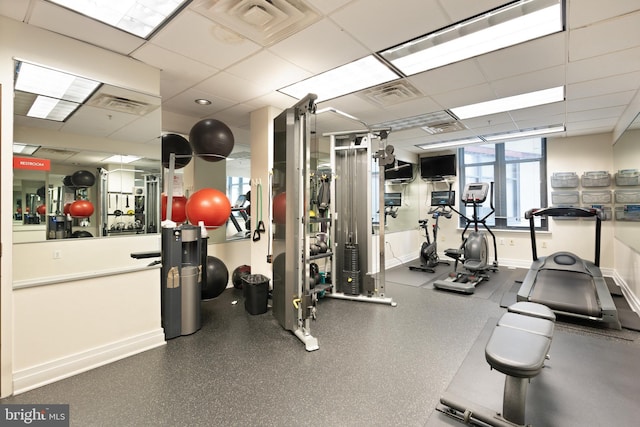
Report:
517,207,621,329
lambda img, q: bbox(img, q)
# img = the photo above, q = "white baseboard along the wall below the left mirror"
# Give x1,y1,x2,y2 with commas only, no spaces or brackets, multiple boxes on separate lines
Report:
13,328,166,395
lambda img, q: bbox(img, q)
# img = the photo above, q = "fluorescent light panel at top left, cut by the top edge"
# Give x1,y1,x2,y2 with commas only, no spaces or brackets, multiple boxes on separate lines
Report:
49,0,187,38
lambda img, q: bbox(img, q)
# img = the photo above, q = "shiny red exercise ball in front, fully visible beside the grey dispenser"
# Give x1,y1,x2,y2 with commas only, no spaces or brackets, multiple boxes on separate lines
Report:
186,188,231,227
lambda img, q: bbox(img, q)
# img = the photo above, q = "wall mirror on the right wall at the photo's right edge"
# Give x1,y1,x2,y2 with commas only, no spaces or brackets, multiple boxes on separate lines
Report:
613,114,640,252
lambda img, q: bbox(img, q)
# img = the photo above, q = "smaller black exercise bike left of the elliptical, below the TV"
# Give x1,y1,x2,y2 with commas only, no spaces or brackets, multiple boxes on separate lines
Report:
409,191,455,273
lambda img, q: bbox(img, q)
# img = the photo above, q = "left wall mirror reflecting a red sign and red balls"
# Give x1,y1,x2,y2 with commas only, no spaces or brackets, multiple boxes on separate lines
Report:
12,61,162,243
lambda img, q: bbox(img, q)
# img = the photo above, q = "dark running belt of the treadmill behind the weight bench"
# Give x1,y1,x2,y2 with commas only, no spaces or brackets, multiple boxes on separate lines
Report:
529,270,601,317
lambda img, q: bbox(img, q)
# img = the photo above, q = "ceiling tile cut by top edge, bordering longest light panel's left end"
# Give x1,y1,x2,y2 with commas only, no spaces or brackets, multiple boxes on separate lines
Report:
330,0,451,51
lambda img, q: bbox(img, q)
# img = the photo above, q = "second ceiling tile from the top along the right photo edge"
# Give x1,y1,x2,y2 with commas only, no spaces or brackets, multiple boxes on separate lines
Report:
569,10,640,61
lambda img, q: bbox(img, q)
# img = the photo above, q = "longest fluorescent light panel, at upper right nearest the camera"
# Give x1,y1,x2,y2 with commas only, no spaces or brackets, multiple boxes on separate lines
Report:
380,0,564,76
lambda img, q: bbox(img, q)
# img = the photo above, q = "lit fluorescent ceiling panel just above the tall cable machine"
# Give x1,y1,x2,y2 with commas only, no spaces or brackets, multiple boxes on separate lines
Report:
278,55,400,102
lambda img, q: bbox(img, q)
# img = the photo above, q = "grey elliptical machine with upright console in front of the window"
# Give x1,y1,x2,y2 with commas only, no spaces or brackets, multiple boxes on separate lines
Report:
433,182,498,294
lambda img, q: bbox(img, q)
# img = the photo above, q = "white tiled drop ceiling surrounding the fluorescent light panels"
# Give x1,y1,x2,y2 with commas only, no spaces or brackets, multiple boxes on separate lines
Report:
0,0,640,153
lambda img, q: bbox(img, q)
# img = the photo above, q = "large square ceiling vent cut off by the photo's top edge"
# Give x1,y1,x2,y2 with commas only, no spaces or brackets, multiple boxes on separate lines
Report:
193,0,320,46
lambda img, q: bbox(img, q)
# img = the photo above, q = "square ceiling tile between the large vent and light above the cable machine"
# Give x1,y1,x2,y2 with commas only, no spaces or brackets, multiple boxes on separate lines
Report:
269,19,370,73
